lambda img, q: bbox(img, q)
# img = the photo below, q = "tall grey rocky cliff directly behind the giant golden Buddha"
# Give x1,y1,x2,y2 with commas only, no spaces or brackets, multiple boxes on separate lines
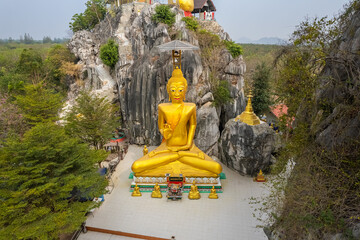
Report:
68,3,245,152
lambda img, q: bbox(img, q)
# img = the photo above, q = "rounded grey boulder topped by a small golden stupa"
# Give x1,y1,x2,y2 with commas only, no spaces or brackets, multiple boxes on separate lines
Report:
219,119,278,176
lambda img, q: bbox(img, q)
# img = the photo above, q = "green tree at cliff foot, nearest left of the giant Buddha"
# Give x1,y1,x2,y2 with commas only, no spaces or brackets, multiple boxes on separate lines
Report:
65,91,120,148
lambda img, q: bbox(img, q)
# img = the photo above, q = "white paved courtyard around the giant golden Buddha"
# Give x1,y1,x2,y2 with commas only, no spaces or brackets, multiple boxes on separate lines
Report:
78,145,267,240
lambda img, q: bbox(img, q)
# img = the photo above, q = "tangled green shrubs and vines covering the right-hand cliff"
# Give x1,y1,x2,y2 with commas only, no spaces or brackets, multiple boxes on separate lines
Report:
258,1,360,239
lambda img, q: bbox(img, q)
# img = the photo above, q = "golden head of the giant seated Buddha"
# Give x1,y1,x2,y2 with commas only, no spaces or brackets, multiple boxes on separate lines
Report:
166,69,187,103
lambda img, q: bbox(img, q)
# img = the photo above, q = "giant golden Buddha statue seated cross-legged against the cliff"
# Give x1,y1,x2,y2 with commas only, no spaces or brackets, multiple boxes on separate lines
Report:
132,68,222,177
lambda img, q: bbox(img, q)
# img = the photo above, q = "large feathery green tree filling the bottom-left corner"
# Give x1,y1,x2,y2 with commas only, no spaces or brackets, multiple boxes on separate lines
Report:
0,123,107,239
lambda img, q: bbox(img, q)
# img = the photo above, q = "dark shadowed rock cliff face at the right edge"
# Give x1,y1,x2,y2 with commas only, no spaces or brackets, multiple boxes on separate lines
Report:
312,11,360,152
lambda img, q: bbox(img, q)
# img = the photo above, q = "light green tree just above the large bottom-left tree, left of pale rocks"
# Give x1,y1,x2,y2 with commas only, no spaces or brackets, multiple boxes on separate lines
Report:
16,83,63,125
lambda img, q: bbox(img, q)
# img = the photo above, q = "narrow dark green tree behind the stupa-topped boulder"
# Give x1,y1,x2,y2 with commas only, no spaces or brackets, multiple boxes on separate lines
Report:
252,62,272,115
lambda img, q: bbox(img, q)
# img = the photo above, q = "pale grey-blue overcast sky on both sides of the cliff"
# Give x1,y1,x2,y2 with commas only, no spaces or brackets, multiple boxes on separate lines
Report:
0,0,349,40
